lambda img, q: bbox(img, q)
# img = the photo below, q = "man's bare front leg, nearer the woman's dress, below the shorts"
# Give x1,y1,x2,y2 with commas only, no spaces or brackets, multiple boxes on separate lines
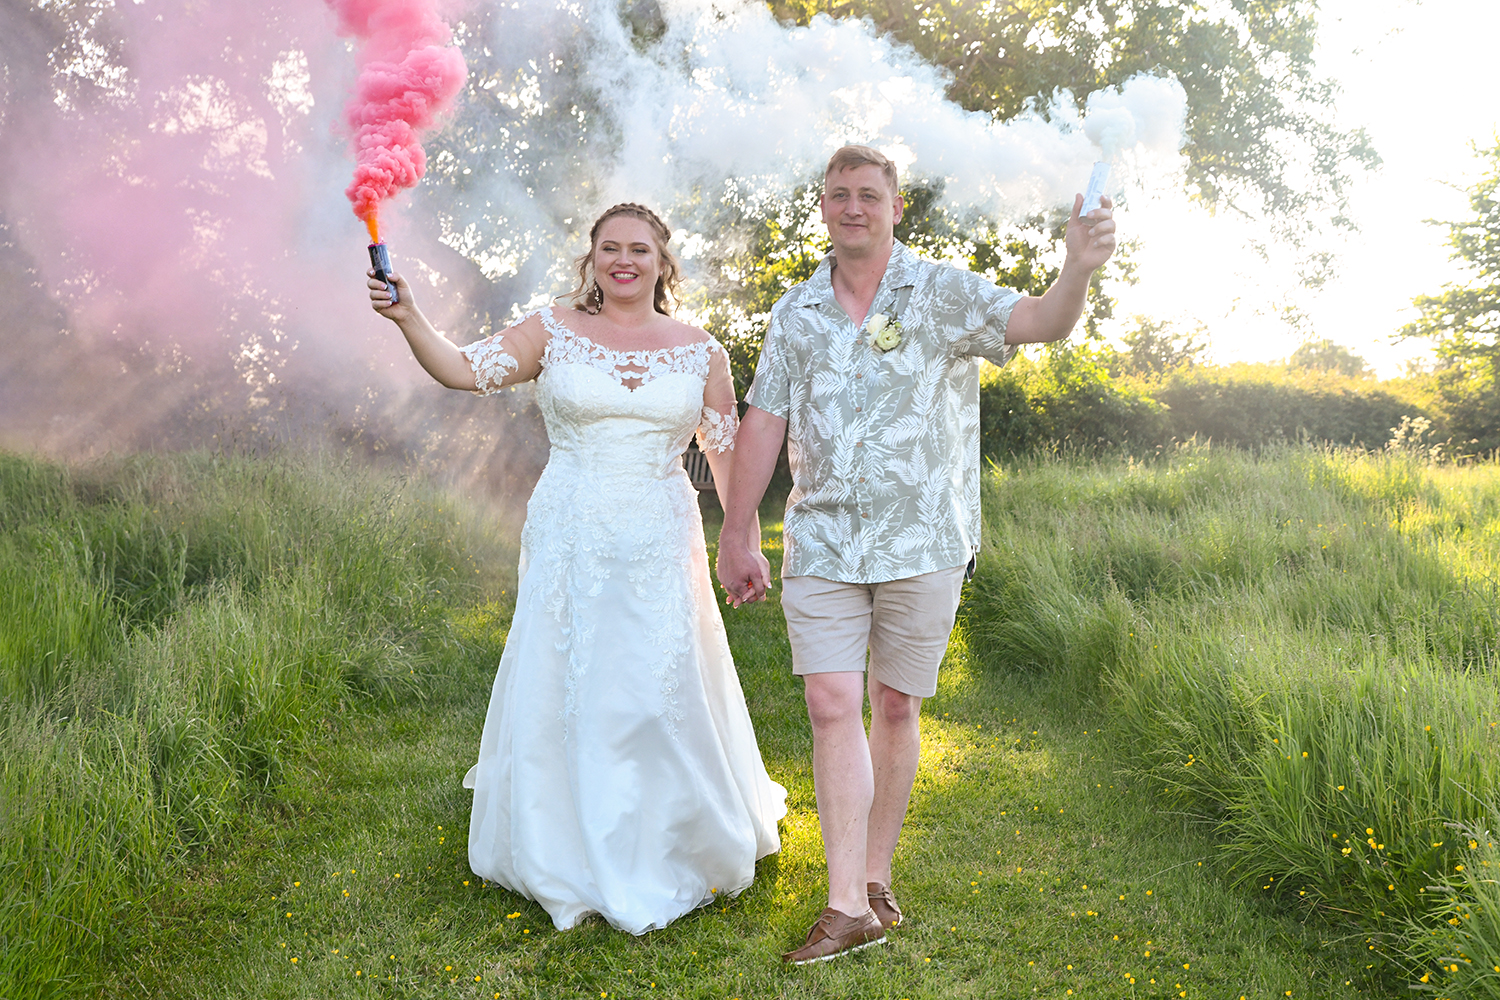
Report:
804,672,890,916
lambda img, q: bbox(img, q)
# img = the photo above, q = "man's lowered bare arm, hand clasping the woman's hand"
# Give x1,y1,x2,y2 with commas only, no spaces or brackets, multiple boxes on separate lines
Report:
716,406,786,607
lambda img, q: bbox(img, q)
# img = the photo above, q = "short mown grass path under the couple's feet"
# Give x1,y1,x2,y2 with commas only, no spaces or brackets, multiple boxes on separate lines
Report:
101,491,1406,1000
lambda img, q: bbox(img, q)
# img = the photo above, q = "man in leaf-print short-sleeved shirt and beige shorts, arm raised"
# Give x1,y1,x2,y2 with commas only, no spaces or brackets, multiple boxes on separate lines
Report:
717,145,1115,964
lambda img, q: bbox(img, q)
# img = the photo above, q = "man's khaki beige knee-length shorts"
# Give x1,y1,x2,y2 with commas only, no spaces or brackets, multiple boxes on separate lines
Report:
782,567,965,697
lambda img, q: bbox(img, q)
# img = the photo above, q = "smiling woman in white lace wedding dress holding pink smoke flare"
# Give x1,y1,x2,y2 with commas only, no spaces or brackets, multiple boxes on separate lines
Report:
369,204,786,934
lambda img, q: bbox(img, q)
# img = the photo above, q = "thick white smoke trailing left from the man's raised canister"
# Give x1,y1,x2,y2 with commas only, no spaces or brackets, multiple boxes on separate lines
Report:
603,0,1185,219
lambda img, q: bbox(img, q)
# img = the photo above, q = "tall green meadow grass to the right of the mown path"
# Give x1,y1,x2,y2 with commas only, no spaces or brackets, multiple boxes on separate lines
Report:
968,450,1500,996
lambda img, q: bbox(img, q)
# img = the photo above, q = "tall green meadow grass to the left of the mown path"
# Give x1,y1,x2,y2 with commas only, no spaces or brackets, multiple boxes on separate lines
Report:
0,454,513,999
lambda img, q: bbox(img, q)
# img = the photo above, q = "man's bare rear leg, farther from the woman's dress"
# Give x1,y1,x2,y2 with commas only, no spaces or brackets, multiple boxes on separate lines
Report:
864,676,923,886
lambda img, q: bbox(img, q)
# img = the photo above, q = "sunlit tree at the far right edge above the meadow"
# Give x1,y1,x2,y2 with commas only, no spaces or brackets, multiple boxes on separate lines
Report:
1398,144,1500,451
